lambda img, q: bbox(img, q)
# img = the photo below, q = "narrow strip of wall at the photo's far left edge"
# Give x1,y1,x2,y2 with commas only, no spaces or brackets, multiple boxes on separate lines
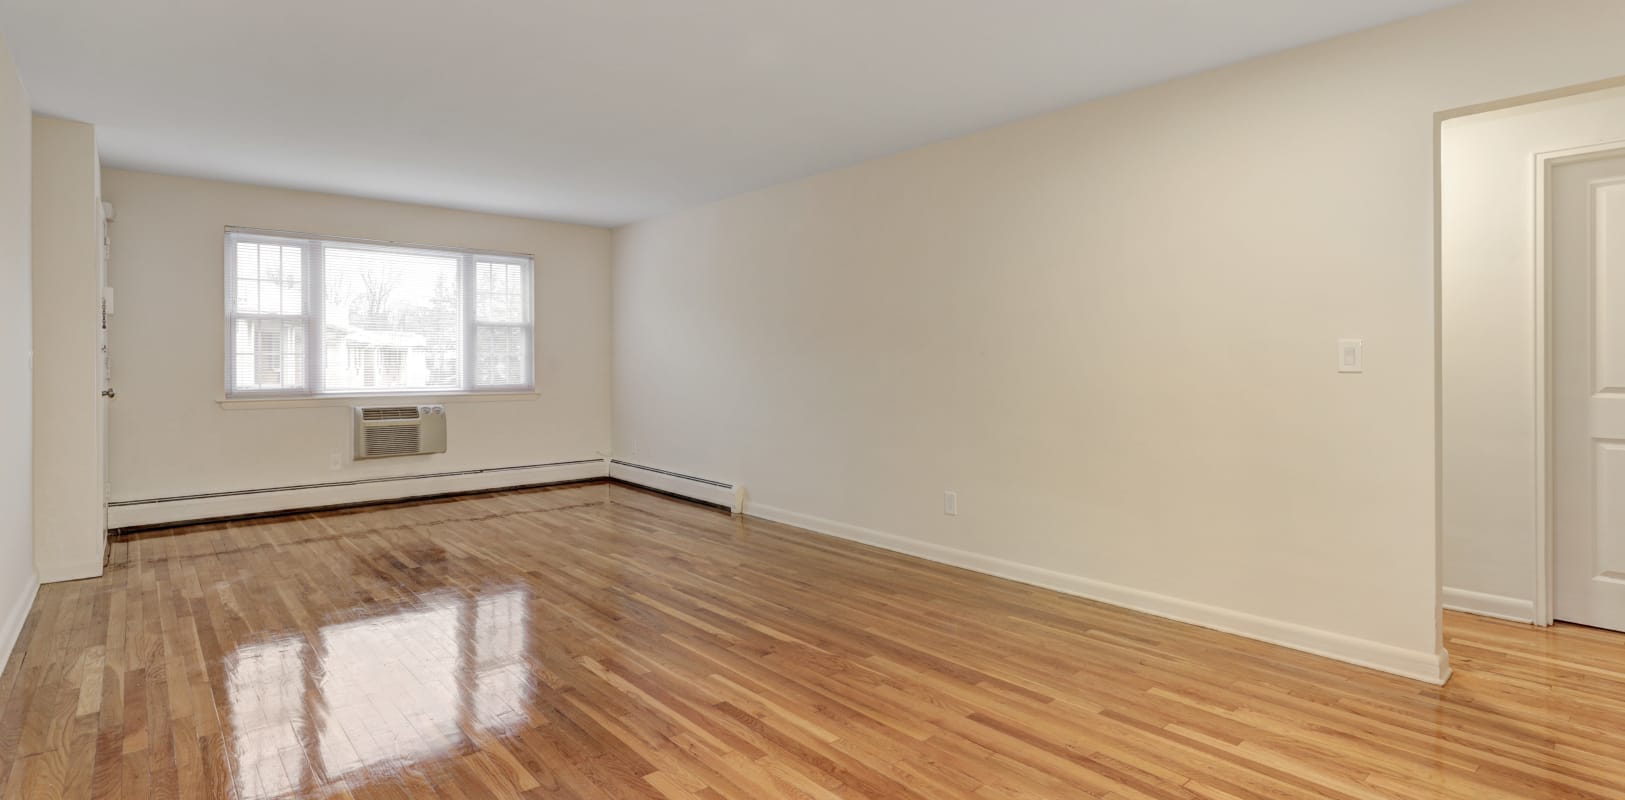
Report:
0,31,39,663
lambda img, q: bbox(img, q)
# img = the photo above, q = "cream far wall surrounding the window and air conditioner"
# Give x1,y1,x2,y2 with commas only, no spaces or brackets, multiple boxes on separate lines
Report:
104,169,611,501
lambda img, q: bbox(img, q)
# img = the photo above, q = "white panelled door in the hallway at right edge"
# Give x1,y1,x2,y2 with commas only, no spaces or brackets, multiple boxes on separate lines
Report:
1550,151,1625,631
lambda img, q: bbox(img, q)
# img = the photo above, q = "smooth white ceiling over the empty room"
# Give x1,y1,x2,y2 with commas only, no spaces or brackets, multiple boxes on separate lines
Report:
0,0,1454,224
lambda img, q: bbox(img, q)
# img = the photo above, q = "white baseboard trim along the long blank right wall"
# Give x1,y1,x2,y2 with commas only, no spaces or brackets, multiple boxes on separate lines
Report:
749,502,1450,685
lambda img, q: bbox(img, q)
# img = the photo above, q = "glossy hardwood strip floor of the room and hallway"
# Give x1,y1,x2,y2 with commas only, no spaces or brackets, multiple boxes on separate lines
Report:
0,485,1625,800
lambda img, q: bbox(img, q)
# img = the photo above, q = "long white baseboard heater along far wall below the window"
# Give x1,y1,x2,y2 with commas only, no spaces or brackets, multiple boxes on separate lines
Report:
107,459,609,528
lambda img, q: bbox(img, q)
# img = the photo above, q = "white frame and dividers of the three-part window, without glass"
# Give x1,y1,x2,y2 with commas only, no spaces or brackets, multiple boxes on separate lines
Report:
221,226,536,400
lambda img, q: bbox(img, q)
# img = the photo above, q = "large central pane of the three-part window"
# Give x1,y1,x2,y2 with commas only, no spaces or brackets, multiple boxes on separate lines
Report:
322,246,463,392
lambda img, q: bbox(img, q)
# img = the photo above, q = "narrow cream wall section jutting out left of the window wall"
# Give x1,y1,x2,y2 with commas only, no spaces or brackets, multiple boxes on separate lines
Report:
33,117,106,582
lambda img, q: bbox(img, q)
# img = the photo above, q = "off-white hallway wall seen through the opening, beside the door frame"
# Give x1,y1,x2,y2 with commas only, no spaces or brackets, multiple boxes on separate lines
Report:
1440,88,1625,620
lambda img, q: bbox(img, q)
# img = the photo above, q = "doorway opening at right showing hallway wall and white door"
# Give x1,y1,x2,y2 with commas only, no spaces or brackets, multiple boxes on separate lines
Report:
1440,86,1625,631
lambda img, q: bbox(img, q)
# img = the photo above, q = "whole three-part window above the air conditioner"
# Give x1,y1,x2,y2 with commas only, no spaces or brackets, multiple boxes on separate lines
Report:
226,229,535,397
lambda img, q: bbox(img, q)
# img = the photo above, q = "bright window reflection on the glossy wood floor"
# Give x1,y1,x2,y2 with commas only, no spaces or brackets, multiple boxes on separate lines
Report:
226,589,531,798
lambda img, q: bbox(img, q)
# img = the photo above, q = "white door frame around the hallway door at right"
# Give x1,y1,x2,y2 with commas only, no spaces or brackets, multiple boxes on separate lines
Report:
1534,140,1625,628
